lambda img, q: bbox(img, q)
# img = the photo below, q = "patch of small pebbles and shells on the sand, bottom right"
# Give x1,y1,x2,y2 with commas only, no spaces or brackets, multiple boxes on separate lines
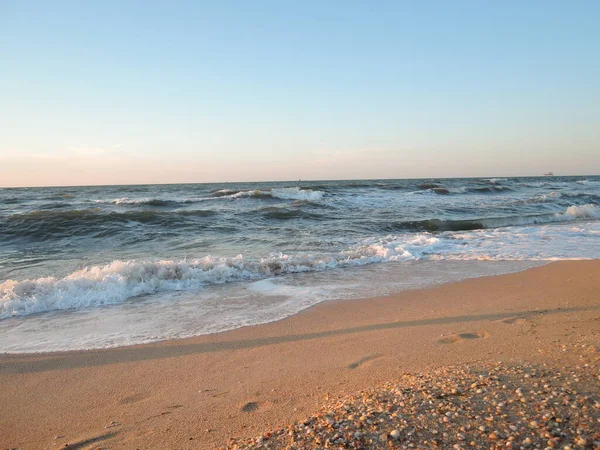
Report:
227,351,600,450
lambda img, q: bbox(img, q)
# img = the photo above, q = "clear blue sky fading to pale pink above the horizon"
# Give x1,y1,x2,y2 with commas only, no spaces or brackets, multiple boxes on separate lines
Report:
0,0,600,187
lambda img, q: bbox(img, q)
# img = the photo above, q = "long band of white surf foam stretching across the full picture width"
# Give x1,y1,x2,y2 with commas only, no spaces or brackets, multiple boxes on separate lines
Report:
0,214,600,319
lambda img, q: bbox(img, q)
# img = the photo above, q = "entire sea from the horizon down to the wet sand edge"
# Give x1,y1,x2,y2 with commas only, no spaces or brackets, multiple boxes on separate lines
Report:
0,176,600,352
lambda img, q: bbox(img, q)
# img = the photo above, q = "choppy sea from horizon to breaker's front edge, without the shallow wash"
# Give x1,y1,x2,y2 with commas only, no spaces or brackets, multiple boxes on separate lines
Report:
0,176,600,324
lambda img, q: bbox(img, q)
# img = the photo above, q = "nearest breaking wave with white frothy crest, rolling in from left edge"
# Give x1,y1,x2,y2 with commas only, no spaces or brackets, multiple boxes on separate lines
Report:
0,244,418,319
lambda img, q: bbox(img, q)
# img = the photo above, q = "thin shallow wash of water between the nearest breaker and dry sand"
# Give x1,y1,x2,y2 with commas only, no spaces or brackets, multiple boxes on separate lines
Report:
0,261,539,353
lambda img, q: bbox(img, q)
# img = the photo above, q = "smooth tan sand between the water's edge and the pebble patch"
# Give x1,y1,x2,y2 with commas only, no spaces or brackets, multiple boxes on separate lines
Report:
0,260,600,449
